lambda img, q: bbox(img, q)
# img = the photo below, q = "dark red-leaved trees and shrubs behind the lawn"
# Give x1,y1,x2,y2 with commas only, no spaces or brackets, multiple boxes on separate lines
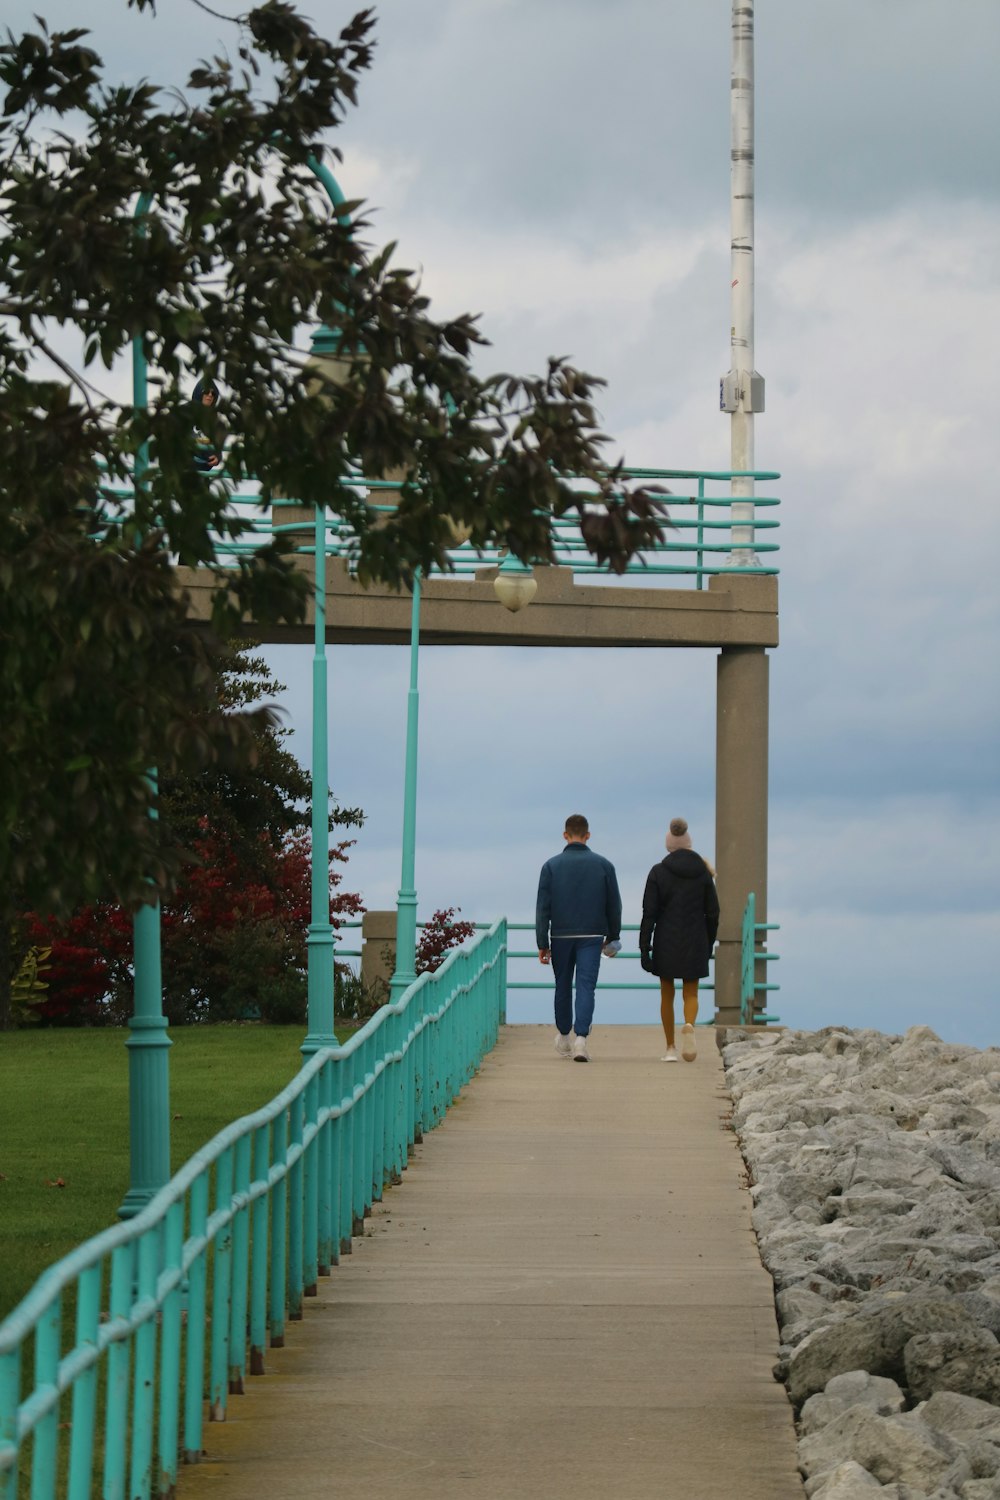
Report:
19,647,364,1026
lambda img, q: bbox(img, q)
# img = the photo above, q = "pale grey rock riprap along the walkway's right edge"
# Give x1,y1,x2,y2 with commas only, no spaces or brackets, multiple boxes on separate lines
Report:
723,1026,1000,1500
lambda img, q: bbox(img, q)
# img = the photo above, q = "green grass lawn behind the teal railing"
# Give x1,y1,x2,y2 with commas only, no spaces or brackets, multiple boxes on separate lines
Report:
0,1026,352,1319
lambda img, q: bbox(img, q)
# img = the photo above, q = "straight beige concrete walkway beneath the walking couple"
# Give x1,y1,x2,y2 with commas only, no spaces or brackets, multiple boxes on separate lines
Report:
180,1026,804,1500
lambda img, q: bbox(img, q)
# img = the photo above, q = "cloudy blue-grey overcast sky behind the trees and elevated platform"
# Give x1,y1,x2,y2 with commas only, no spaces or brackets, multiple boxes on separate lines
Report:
7,0,1000,1046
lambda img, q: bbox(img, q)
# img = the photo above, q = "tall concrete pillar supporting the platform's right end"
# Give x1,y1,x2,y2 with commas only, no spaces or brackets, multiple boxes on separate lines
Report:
715,647,768,1026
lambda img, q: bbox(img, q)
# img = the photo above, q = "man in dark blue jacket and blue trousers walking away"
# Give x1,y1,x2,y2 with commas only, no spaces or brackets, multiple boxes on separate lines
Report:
535,813,622,1062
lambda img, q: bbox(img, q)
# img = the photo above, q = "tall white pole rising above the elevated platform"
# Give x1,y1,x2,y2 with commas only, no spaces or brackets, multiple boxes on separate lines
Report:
720,0,765,567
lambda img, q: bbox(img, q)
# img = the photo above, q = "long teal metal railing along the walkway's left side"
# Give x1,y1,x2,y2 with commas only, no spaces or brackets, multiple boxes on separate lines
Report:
0,920,507,1500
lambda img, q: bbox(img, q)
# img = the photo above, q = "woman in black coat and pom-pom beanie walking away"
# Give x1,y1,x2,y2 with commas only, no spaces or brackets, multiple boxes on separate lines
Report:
639,818,718,1062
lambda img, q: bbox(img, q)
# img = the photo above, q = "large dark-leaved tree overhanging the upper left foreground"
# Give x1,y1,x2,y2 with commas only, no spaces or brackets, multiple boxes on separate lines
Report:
0,0,664,1025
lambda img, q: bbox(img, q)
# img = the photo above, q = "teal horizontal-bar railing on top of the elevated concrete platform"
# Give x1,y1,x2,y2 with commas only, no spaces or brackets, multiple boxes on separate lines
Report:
95,468,781,590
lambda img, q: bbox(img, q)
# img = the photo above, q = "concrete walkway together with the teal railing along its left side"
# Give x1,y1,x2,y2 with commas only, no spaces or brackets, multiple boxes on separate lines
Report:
0,921,802,1500
